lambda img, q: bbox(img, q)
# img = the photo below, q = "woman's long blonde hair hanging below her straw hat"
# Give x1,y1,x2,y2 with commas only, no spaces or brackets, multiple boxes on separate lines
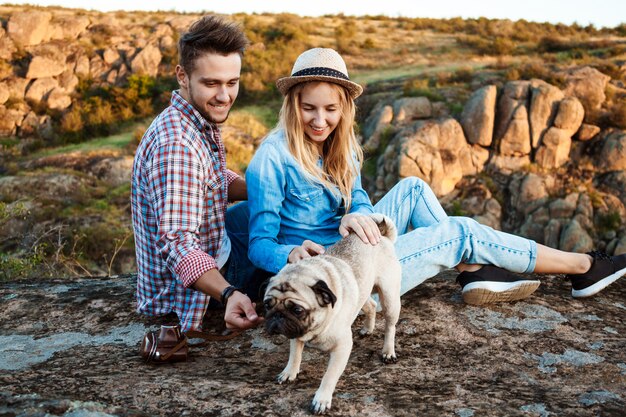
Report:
278,81,363,212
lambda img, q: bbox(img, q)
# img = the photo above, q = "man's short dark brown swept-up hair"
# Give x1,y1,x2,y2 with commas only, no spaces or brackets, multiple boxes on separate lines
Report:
178,15,249,74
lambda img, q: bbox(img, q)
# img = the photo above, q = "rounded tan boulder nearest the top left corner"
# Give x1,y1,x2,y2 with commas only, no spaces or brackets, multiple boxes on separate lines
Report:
7,10,52,46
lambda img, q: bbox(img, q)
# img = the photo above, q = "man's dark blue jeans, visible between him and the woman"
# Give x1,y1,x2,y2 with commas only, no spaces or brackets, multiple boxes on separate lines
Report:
224,201,272,300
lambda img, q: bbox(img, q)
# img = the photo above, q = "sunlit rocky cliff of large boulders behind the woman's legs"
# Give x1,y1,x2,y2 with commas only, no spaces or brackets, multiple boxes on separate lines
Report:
362,67,626,253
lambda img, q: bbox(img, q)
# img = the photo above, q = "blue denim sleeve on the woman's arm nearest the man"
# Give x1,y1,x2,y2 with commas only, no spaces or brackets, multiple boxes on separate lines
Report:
246,143,297,273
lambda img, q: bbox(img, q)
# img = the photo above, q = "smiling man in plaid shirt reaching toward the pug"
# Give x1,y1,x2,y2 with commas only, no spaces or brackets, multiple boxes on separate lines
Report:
131,16,262,332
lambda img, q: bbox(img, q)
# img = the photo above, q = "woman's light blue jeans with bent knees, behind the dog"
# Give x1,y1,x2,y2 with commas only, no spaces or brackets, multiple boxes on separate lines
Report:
374,177,537,294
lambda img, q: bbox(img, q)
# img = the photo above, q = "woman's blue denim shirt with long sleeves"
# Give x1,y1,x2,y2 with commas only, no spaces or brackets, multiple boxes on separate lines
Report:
246,129,374,273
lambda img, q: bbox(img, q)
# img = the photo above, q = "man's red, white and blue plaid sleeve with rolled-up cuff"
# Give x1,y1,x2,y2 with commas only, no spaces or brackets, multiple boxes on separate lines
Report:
148,142,217,287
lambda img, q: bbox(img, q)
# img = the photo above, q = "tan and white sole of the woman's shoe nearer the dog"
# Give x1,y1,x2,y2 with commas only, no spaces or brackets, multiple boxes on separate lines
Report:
463,281,541,306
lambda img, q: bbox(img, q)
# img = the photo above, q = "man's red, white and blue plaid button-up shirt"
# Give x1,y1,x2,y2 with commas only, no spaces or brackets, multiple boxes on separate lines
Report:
131,91,238,331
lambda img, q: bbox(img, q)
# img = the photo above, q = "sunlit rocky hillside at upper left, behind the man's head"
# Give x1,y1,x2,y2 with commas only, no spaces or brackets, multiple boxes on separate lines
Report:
0,6,188,138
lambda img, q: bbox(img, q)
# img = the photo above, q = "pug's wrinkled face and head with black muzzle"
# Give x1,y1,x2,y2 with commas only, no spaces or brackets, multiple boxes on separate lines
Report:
263,260,337,339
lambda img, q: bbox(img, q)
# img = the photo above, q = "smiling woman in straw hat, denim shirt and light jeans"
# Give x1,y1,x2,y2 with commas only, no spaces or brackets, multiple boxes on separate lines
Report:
246,48,626,305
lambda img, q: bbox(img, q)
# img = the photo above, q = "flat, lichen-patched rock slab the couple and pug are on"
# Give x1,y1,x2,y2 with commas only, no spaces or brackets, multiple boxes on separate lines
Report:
0,272,626,417
